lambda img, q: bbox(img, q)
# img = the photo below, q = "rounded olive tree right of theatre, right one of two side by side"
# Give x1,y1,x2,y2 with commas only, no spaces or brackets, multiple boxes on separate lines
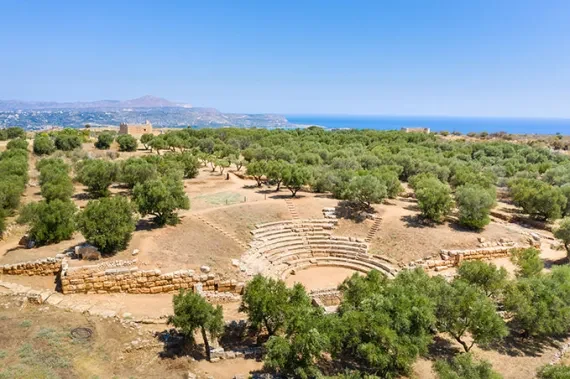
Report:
455,184,495,229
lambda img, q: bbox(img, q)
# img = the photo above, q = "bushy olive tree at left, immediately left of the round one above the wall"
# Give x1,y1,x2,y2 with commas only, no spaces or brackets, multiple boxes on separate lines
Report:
18,199,76,245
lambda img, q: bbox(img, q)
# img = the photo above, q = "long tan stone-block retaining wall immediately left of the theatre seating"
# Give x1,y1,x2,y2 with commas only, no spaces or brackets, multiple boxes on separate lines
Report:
61,264,244,302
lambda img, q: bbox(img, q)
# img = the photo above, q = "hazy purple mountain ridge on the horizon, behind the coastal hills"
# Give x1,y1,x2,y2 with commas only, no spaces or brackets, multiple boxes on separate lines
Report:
0,95,192,111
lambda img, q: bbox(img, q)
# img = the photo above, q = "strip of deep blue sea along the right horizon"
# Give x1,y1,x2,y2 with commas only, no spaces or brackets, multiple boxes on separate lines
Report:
285,115,570,135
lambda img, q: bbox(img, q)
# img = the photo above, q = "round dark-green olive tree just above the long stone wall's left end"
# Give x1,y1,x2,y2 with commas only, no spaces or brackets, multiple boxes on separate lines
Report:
77,196,136,253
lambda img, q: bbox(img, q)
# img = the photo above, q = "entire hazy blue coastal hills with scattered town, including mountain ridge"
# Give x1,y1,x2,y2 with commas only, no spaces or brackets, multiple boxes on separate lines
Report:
0,96,295,130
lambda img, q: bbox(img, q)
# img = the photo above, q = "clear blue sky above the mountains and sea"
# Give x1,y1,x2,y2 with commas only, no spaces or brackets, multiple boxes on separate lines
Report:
0,0,570,117
